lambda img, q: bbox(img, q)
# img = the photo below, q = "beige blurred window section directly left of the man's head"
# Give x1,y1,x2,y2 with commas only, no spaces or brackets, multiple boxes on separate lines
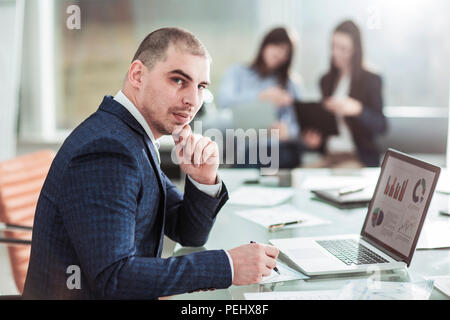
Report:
55,0,136,128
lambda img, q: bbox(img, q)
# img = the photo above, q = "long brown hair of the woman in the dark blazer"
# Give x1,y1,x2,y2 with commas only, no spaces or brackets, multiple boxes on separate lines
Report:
326,20,364,95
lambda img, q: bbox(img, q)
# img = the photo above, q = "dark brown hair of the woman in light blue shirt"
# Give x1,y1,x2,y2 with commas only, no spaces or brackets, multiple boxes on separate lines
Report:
250,27,294,88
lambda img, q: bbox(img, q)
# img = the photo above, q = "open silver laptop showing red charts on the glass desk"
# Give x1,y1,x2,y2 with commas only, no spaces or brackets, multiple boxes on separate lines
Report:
269,149,440,276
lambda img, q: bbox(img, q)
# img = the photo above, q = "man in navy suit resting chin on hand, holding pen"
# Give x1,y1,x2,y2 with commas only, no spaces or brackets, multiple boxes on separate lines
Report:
23,28,278,299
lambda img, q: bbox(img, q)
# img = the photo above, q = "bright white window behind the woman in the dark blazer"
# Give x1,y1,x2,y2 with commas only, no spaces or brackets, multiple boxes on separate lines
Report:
298,0,450,107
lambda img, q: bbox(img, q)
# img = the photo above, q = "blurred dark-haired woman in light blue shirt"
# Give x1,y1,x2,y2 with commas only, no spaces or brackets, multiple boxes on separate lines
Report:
217,27,302,168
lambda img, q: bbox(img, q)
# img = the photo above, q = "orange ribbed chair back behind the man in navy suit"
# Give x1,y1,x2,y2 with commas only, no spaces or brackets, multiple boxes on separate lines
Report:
0,150,55,294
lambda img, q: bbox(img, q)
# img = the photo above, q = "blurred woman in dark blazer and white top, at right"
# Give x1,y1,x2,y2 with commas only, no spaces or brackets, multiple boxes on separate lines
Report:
302,21,387,167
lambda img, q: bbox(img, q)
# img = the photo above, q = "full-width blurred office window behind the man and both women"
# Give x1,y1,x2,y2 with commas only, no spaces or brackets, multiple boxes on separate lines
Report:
21,0,450,134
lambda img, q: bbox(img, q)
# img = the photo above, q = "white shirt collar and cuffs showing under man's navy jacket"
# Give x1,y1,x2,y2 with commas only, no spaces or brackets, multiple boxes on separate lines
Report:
114,90,234,279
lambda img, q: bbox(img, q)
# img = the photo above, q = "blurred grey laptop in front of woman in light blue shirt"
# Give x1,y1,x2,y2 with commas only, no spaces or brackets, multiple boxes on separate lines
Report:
233,101,277,130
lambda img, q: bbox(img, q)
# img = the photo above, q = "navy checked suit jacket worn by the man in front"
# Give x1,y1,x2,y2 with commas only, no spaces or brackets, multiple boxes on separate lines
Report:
23,96,232,299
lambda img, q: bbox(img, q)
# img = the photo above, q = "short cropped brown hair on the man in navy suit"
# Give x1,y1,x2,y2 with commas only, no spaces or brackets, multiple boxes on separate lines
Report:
131,28,211,69
